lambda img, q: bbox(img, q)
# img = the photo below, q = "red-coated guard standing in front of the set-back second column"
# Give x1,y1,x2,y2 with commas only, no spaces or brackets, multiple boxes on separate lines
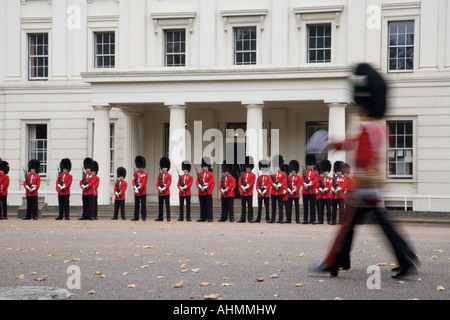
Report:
131,156,148,221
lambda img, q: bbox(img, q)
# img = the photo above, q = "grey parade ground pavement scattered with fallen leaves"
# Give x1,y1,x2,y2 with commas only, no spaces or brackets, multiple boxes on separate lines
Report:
0,217,450,303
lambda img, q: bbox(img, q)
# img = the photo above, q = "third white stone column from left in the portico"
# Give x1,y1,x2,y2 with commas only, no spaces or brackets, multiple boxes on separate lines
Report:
165,103,187,206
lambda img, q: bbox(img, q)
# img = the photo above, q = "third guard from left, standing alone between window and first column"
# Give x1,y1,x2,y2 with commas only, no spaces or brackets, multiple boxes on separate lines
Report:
55,159,73,220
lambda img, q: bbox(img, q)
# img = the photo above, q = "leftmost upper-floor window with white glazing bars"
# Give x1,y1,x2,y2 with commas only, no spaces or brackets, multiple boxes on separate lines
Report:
28,33,48,80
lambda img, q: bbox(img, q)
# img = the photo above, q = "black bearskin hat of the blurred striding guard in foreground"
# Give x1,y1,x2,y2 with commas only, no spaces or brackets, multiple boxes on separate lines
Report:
351,63,387,119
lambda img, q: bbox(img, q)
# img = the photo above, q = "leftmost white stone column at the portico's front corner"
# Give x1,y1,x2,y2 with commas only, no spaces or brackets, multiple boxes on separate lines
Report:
93,106,111,205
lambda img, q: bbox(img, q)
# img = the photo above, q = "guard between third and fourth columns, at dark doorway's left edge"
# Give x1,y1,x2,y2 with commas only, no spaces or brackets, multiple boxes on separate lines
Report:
218,160,236,222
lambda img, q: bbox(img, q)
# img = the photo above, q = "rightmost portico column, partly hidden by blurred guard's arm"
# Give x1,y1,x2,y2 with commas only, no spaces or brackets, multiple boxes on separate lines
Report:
327,102,347,166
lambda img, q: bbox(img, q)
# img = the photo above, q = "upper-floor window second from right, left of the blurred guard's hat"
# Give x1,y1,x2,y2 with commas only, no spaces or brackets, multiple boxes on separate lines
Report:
308,24,331,63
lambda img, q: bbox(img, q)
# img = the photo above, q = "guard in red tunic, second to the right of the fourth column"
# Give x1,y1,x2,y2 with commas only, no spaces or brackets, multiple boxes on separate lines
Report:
268,155,287,223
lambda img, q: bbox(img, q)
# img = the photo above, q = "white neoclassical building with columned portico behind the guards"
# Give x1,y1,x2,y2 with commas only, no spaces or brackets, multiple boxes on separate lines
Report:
0,0,450,211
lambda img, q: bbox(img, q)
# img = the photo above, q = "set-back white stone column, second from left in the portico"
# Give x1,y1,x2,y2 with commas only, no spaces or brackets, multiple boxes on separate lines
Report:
123,111,142,203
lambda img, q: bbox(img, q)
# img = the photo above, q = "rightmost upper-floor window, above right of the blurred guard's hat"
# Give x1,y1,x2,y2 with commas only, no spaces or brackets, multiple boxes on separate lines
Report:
388,21,414,72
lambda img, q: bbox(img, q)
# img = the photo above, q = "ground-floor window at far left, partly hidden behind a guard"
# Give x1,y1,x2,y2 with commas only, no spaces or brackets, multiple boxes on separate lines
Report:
28,124,47,176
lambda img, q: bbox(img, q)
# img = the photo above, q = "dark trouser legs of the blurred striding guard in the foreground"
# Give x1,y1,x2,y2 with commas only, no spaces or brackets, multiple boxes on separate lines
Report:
326,207,416,268
